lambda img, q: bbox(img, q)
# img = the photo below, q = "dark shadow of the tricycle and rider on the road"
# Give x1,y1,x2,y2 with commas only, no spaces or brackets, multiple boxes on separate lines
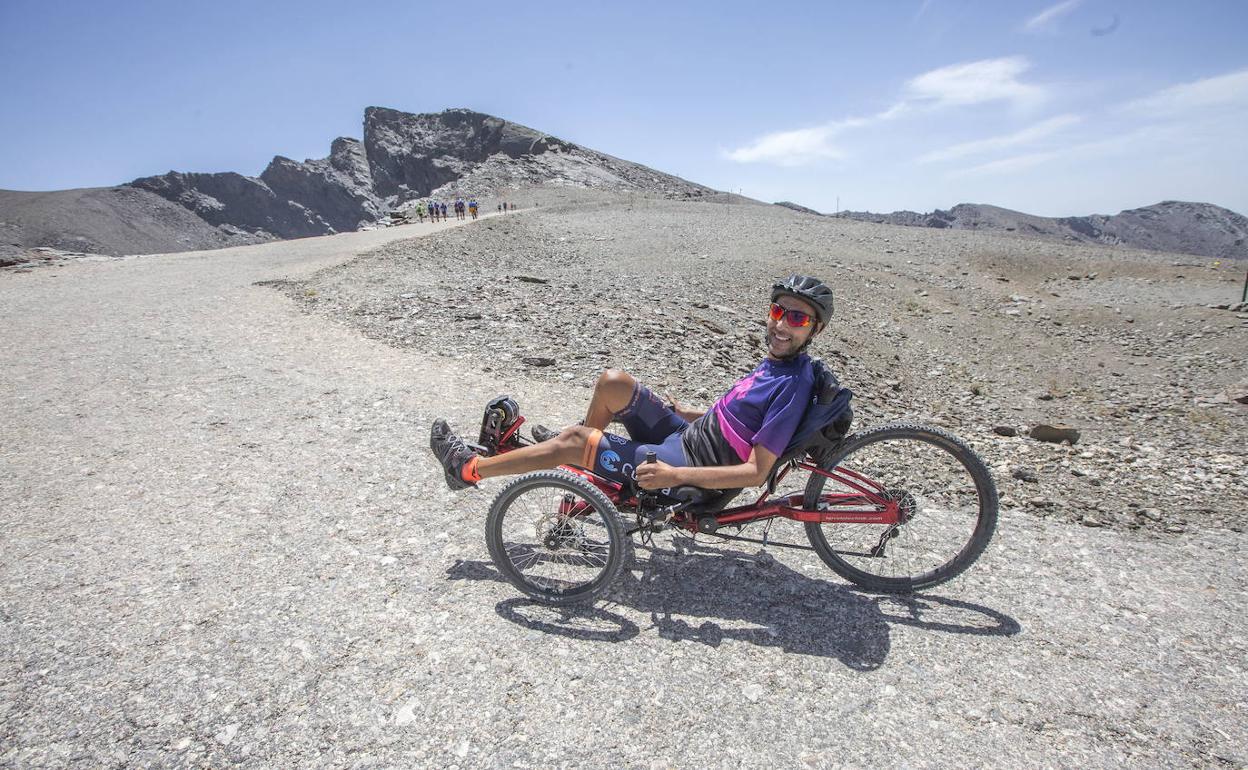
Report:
447,535,1021,671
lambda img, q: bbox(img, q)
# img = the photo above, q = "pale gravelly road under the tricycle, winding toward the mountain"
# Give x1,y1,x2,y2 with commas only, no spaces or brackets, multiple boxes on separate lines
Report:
0,213,1248,768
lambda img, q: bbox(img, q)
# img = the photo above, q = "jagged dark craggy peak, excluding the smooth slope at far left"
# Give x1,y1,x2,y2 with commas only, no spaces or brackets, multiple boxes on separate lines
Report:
131,107,716,238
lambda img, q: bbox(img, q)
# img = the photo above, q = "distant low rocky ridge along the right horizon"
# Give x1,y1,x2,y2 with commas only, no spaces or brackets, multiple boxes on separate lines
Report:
833,201,1248,260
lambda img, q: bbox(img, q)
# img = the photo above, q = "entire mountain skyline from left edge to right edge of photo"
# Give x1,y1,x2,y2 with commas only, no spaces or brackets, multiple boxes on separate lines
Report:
0,106,1248,265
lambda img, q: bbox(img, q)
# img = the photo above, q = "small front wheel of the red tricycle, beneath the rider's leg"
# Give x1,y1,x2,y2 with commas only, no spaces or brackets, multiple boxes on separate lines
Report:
485,470,625,605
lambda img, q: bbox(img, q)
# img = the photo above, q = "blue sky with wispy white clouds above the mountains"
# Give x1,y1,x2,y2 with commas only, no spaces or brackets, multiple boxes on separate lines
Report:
0,0,1248,216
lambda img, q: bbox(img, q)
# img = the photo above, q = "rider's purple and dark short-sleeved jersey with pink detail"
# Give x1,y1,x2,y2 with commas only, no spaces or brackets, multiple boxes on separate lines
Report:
683,353,815,465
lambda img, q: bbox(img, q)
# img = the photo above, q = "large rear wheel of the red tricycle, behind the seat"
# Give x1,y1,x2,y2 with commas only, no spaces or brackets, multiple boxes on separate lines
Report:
802,424,997,593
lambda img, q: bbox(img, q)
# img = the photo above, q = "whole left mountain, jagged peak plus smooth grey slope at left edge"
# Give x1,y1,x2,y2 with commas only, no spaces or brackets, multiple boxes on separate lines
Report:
0,107,718,262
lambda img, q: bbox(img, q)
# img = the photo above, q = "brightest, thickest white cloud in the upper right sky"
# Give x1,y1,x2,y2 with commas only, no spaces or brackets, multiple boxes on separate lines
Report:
906,56,1045,106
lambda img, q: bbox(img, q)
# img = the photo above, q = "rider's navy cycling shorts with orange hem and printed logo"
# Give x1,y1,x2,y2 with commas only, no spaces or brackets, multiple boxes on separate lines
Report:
582,383,689,484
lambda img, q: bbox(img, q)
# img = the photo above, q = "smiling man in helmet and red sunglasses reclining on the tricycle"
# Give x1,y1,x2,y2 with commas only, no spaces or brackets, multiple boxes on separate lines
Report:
429,275,832,489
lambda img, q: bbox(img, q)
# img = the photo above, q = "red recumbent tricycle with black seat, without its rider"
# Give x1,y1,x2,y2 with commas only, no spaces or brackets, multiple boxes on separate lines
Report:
464,361,997,605
